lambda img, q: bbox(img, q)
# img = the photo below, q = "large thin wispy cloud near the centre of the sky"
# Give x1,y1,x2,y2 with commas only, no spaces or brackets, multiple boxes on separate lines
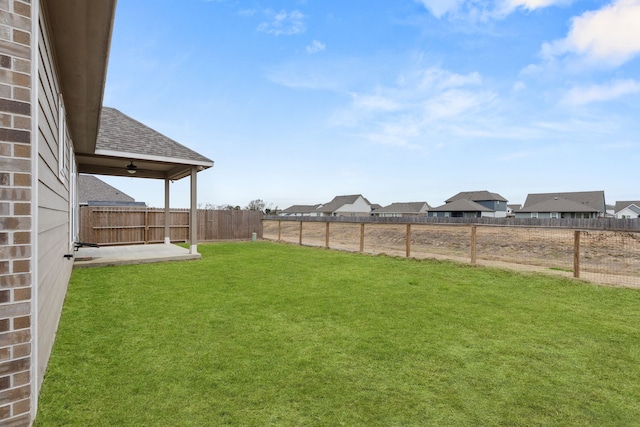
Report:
332,67,496,149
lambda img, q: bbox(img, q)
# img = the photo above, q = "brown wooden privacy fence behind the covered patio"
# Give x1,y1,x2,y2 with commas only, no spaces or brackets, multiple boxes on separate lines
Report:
79,206,262,246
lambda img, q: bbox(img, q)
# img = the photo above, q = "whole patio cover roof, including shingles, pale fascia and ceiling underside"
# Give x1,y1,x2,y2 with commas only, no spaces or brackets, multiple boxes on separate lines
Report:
76,107,213,179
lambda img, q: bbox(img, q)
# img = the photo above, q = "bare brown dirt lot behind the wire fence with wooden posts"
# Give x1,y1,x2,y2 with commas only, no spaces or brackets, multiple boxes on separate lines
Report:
263,220,640,288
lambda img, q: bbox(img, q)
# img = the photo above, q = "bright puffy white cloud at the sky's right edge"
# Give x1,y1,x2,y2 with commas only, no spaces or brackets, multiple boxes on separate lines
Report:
542,0,640,66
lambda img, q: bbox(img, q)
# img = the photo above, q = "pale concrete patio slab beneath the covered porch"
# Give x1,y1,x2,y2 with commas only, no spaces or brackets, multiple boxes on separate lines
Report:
73,243,202,268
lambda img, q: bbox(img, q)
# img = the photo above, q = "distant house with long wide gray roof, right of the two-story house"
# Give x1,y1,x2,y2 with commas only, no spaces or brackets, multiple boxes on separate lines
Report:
516,191,607,218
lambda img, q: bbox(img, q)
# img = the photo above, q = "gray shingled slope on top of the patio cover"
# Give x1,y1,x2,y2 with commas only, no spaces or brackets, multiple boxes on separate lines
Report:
96,107,213,163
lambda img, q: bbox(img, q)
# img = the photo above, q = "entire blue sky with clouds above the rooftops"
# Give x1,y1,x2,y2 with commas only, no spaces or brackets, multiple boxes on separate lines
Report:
104,0,640,209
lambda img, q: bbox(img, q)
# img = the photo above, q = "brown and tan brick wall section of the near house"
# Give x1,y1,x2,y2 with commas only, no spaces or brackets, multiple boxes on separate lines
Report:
0,0,35,426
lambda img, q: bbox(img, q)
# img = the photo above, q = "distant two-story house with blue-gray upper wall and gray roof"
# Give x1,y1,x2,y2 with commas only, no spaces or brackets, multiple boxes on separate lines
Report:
429,190,507,218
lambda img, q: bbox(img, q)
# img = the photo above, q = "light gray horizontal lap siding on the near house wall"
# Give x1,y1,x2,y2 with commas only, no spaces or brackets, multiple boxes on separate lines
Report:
37,10,73,392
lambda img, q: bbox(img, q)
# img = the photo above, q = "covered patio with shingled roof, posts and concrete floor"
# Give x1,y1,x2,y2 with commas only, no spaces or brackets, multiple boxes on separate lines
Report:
76,107,213,258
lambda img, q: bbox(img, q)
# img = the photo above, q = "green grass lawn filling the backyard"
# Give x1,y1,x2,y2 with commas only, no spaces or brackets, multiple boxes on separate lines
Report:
35,242,640,427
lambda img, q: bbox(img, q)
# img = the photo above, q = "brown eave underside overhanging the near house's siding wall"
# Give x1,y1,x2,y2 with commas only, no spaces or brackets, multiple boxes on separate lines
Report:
47,0,116,153
